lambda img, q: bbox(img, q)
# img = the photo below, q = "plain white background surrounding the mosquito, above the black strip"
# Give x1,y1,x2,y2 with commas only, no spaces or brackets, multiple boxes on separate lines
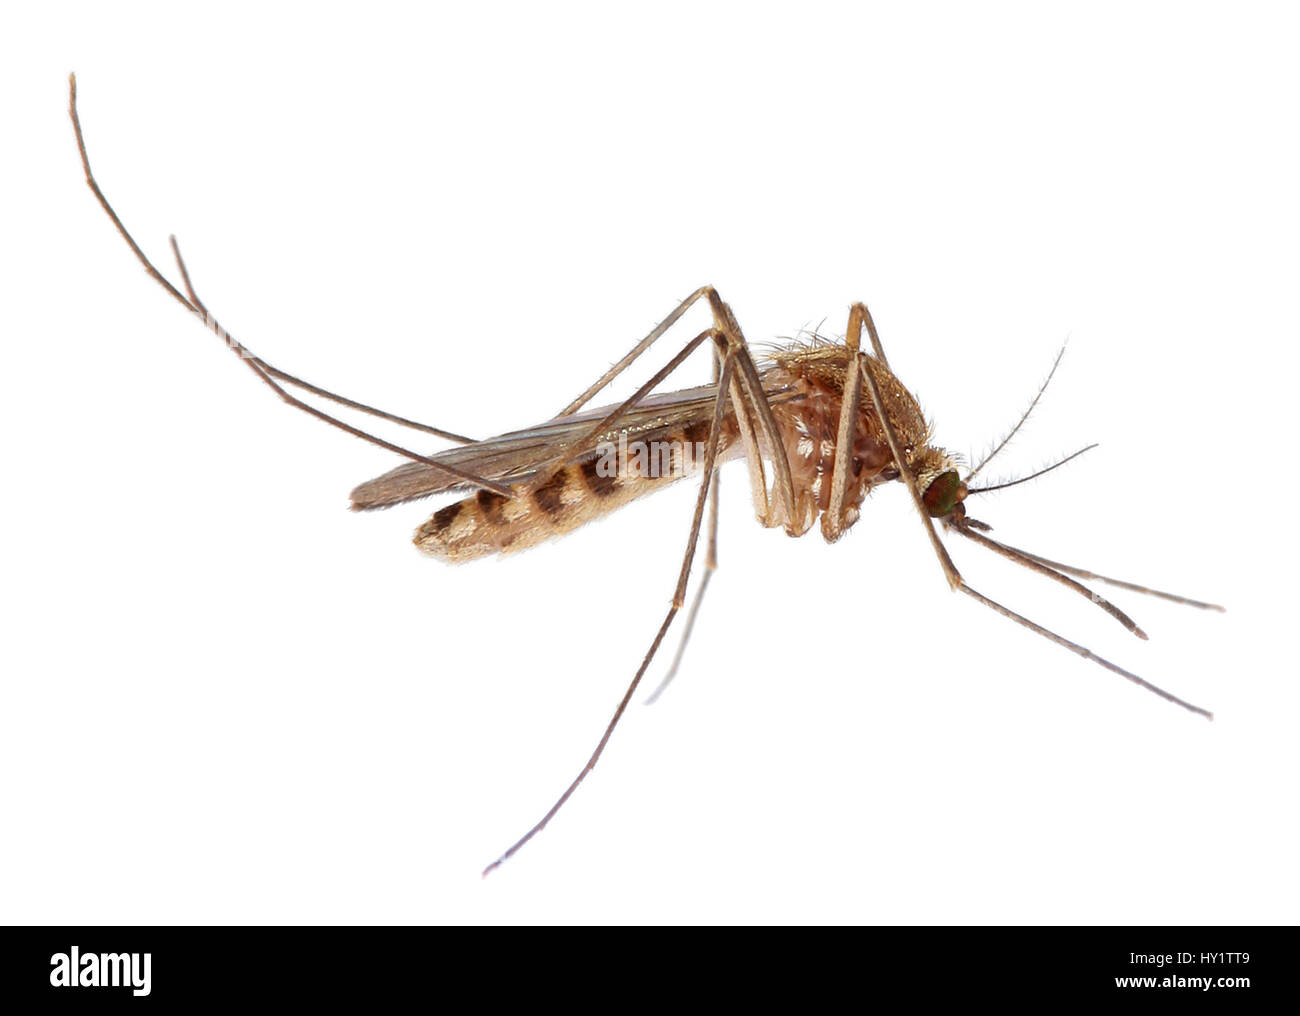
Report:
0,3,1300,924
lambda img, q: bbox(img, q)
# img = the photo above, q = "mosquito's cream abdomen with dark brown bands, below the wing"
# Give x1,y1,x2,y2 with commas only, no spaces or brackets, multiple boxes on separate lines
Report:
415,425,709,561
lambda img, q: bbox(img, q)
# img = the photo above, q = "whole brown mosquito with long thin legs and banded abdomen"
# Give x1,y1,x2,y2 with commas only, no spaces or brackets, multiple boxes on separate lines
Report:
69,75,1223,876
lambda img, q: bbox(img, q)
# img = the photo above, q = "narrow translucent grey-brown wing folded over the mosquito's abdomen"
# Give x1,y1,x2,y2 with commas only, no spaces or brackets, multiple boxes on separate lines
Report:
352,385,769,511
